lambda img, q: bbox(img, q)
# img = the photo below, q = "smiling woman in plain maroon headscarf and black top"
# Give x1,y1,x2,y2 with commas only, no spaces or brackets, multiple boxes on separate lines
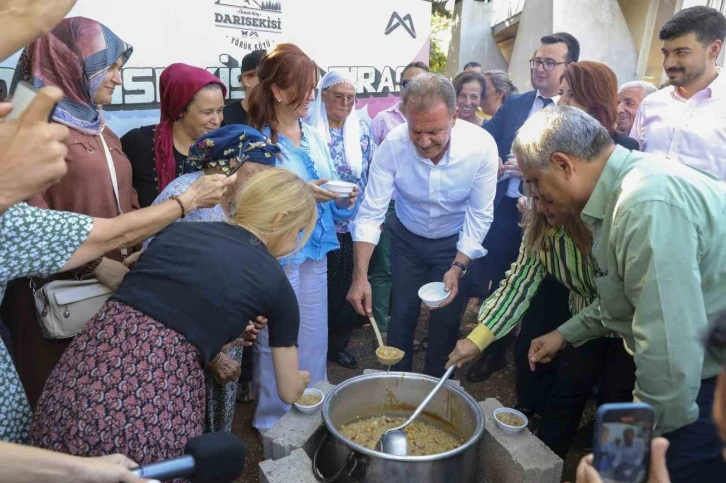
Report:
121,64,227,208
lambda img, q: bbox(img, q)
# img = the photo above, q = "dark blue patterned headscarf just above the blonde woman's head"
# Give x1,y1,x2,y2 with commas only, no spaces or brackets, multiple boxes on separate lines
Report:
184,124,280,174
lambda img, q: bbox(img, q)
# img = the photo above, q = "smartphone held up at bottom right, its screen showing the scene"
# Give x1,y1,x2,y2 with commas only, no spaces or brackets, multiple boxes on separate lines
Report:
593,403,655,483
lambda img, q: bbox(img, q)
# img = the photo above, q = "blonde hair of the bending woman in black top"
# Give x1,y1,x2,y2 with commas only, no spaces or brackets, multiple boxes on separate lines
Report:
229,168,318,255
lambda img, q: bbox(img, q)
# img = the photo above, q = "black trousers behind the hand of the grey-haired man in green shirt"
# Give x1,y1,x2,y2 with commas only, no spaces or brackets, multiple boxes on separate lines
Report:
514,277,570,412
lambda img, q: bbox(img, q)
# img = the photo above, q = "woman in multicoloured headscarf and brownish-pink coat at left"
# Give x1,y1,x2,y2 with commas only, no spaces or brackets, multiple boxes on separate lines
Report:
2,17,138,405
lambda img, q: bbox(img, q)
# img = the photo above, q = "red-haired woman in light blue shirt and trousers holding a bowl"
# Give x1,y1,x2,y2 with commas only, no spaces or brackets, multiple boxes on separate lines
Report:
249,43,358,429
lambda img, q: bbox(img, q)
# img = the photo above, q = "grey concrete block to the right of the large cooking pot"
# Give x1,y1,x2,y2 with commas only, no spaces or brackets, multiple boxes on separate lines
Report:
477,398,563,483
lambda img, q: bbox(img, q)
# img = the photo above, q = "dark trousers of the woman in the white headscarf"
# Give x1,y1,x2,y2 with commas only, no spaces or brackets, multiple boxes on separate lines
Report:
328,233,362,353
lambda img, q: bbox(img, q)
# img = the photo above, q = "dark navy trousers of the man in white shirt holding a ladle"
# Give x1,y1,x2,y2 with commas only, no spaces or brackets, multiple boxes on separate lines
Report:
385,216,468,377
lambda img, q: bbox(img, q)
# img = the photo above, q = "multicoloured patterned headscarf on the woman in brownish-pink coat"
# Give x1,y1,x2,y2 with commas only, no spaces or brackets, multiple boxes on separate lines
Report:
10,17,133,135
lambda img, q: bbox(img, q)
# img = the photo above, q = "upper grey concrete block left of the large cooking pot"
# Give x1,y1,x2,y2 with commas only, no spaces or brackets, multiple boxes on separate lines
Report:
262,381,334,460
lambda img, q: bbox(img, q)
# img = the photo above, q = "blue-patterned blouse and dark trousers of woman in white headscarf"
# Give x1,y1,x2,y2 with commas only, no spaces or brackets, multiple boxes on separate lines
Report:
328,120,376,353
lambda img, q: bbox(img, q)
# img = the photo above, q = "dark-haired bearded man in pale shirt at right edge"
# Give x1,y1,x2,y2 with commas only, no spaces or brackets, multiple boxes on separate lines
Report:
630,7,726,180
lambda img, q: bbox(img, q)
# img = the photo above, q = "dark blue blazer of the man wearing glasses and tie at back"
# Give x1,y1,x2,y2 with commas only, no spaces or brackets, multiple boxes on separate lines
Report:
482,91,537,210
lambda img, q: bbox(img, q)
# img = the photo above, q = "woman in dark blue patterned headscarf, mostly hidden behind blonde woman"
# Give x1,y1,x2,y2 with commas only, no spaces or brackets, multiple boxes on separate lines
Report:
147,124,280,432
